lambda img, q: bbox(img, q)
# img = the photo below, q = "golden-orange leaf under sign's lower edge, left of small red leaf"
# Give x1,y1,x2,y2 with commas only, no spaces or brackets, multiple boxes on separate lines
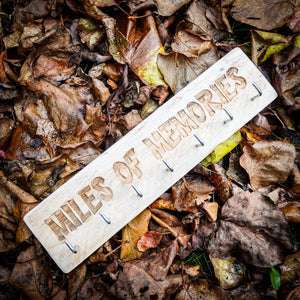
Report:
120,209,151,259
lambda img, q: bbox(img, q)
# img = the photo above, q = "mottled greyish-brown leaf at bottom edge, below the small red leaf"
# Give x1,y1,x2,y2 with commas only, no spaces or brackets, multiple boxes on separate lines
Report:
110,263,182,300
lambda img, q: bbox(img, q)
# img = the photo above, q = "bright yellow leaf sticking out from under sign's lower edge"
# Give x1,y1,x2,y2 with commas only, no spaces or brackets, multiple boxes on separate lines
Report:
201,130,242,167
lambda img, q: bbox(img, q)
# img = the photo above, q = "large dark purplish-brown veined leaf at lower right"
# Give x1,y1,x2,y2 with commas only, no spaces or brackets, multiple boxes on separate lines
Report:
208,189,293,267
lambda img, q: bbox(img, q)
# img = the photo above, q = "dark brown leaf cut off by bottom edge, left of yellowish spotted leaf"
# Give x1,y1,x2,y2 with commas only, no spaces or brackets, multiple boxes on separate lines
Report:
174,279,231,300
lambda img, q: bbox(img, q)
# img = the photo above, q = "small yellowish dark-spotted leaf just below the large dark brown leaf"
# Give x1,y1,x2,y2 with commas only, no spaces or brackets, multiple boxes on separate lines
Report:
210,257,246,290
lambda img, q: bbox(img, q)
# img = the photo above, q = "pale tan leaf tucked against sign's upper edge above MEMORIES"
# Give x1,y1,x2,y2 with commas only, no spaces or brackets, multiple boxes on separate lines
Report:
157,48,217,94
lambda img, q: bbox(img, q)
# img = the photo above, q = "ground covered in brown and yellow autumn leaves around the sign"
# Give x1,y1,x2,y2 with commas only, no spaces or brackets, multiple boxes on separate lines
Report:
0,0,300,299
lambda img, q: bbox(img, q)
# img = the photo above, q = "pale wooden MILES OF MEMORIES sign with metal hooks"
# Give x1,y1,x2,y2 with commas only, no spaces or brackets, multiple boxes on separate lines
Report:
24,48,277,273
